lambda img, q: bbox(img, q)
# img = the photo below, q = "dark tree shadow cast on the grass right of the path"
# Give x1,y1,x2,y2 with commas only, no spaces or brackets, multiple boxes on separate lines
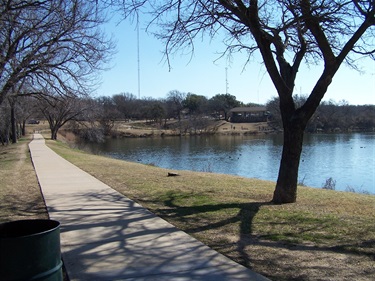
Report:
148,193,375,280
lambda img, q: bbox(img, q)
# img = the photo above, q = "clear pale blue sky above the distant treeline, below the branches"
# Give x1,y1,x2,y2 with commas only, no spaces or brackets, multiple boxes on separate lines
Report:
97,15,375,105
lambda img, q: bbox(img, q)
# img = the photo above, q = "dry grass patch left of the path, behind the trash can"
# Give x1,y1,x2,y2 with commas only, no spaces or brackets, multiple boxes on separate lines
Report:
0,139,48,222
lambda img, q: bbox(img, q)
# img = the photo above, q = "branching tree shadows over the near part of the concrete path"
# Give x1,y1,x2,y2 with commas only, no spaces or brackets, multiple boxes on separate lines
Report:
49,190,264,280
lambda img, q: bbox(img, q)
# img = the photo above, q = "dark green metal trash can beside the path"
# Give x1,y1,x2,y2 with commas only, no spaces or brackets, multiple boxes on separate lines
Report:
0,220,63,281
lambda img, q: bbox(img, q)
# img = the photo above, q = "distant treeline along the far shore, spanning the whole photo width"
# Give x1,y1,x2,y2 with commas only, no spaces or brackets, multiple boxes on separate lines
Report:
0,90,375,144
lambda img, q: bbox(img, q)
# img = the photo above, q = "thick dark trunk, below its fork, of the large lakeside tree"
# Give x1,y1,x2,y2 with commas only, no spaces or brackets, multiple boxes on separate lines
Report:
272,120,305,204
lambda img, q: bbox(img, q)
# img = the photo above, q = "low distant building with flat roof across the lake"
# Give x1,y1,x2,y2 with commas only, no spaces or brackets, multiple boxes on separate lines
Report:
228,106,269,123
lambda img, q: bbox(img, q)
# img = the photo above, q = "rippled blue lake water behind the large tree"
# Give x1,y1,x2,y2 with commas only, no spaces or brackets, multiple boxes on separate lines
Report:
83,134,375,194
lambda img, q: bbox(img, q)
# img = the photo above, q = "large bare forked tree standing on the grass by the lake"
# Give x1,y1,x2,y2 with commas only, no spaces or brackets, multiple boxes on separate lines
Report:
112,0,375,203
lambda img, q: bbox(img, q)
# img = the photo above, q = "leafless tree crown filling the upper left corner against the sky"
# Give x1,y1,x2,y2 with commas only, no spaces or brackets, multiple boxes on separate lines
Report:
0,0,113,104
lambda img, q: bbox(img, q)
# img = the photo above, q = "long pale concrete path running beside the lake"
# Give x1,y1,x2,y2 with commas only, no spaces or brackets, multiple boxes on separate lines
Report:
29,134,267,281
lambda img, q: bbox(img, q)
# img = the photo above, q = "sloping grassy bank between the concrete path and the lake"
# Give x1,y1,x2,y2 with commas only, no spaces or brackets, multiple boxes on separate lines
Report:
48,141,375,280
